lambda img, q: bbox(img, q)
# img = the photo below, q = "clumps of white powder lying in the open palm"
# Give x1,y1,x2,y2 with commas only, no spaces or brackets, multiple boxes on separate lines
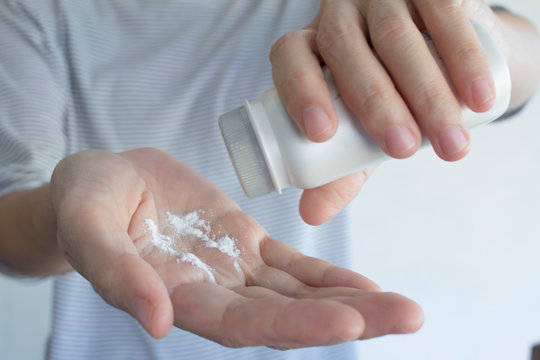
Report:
144,210,241,283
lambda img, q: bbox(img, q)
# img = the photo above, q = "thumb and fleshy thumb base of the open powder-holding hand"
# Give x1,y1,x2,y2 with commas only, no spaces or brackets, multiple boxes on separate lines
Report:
51,151,173,338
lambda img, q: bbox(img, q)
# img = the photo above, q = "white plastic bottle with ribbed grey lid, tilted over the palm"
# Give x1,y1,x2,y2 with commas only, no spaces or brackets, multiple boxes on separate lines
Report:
219,21,511,197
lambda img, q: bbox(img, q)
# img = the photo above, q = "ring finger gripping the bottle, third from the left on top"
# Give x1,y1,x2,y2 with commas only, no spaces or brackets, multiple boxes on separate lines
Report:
366,1,469,161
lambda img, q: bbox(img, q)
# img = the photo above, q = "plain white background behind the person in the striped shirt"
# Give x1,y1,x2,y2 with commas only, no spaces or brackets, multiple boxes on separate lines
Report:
0,0,540,360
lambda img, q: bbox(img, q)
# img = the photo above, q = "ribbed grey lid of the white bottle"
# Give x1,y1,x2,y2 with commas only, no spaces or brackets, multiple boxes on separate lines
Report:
219,107,274,198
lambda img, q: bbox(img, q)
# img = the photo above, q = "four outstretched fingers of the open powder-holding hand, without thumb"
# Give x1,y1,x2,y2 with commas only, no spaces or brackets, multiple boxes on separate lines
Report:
171,233,423,349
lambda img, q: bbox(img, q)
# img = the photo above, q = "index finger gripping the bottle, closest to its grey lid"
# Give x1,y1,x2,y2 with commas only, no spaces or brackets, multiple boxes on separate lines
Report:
270,30,337,142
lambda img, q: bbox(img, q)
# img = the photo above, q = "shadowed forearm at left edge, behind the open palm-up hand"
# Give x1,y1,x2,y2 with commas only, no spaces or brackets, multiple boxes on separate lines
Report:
0,184,71,276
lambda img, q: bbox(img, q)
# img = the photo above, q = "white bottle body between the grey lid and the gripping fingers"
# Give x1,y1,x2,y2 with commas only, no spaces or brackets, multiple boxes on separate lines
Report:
250,87,387,192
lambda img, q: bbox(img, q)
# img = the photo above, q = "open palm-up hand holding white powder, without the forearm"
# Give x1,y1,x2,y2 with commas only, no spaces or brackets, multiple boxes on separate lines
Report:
51,149,422,348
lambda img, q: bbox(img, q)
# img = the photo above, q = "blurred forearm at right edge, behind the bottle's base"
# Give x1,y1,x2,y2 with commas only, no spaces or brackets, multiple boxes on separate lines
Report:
495,9,540,111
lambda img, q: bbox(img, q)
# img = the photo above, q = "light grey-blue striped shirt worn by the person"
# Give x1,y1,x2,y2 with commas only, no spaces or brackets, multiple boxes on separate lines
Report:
0,0,356,360
